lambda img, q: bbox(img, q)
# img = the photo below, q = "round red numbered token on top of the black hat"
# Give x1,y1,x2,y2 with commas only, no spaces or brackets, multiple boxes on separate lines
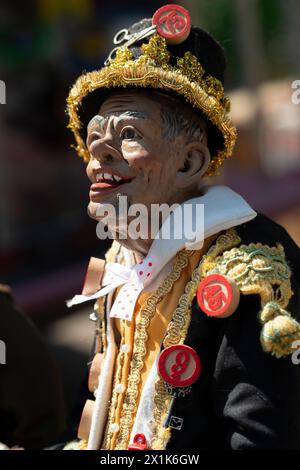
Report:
152,4,191,44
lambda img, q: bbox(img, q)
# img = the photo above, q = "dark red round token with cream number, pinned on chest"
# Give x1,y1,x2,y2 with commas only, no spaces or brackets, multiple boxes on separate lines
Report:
158,344,201,387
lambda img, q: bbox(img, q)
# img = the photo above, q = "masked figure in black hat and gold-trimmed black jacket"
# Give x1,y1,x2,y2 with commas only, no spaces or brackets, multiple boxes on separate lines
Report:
65,5,300,452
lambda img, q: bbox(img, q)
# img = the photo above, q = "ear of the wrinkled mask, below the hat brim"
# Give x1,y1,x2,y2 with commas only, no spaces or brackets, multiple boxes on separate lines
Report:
175,141,211,189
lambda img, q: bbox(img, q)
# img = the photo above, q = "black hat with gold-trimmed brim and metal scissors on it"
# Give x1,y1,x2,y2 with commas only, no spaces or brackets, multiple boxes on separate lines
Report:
67,5,236,175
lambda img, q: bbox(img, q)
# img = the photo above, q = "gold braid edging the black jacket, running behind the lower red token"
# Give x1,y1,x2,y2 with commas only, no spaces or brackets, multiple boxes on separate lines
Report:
151,229,241,450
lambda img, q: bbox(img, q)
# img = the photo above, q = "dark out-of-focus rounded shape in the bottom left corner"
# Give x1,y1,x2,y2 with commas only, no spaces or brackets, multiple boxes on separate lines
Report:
0,292,65,449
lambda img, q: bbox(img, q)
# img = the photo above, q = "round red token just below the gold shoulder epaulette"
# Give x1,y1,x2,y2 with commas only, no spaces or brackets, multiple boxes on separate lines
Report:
197,274,240,318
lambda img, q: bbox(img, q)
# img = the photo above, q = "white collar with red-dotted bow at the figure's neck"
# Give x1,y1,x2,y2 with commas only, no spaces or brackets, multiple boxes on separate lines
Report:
67,186,256,319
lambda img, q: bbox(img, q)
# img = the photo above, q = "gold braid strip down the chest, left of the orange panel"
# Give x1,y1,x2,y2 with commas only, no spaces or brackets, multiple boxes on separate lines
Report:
108,250,193,450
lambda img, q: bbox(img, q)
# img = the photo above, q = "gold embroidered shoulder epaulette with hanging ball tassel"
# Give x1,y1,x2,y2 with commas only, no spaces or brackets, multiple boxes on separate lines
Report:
206,243,300,358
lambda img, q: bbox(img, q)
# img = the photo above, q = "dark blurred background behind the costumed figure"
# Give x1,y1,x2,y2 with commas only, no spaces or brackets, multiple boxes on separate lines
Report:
0,0,300,430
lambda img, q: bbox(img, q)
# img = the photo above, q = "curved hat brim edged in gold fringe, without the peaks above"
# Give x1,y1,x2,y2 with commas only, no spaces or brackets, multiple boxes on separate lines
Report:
67,63,237,176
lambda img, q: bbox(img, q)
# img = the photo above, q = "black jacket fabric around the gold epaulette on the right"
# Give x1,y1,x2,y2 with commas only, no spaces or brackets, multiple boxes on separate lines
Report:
167,215,300,451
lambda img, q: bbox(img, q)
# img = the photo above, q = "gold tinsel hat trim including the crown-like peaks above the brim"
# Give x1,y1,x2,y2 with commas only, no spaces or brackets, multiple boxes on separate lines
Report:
67,35,236,176
